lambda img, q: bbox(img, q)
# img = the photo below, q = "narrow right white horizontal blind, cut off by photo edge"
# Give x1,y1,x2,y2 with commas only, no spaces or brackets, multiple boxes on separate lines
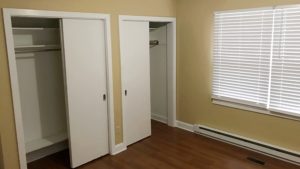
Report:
269,7,300,115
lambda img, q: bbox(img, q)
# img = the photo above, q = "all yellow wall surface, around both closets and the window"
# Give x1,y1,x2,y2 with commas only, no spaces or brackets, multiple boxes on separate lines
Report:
0,0,300,169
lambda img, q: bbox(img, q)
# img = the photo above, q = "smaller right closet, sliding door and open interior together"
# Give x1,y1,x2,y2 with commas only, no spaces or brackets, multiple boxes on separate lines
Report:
120,16,176,145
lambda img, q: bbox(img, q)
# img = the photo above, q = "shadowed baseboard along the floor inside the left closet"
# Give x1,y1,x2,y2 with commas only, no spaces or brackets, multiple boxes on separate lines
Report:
26,141,68,163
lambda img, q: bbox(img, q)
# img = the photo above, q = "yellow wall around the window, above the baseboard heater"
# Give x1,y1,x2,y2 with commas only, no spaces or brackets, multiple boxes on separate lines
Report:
176,0,300,151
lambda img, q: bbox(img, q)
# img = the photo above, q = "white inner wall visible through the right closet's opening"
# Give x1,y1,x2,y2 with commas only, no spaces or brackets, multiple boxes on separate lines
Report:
150,26,168,122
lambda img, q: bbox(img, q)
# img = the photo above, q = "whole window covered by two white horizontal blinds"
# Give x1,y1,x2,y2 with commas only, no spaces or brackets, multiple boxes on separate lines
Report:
212,7,300,116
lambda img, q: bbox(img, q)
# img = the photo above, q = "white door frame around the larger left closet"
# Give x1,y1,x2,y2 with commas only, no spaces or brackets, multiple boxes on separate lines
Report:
3,8,119,169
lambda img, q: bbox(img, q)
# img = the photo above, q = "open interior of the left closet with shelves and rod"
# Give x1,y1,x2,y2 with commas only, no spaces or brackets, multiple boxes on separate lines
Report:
12,17,68,162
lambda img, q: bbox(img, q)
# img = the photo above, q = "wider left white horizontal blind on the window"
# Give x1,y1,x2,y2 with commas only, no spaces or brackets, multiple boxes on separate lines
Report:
213,9,273,107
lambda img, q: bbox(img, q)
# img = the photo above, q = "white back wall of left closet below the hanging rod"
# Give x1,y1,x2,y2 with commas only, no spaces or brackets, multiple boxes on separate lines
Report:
17,51,67,143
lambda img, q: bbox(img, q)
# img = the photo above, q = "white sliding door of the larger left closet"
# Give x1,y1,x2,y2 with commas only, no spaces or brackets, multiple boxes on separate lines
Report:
62,19,108,168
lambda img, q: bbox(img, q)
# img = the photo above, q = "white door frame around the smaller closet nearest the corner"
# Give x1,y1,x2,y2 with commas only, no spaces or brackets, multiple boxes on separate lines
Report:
119,15,177,145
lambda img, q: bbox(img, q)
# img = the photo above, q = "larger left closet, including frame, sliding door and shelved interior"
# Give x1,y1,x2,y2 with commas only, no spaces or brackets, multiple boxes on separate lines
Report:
4,9,109,169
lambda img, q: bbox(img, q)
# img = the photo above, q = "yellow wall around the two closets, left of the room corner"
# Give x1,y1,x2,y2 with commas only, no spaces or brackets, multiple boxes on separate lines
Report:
0,0,176,169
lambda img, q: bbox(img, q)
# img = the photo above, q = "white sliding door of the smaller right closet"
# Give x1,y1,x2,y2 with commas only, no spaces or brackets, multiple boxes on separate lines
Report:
120,21,151,145
